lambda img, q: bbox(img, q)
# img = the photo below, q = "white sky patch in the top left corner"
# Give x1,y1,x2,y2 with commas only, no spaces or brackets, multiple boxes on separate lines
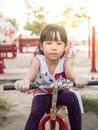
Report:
0,0,25,23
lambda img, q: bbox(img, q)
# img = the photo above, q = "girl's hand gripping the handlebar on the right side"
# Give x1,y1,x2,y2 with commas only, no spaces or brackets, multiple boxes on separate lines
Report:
75,76,89,88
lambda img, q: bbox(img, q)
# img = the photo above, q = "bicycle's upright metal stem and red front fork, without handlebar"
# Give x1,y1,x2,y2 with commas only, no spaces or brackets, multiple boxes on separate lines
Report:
38,83,68,130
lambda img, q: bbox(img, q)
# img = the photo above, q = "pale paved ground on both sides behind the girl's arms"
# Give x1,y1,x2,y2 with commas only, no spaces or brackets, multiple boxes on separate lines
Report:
0,51,98,80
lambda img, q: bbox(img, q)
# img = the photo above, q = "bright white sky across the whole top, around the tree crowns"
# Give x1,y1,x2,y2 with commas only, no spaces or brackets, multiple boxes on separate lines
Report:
0,0,98,38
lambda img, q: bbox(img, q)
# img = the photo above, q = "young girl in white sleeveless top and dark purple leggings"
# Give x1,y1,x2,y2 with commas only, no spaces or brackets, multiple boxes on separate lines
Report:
15,24,88,130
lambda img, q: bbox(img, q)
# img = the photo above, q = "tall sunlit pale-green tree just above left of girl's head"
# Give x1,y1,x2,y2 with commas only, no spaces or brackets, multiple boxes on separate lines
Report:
24,1,46,35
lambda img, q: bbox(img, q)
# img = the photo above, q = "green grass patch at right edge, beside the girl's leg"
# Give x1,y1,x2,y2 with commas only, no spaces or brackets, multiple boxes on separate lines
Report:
82,96,98,114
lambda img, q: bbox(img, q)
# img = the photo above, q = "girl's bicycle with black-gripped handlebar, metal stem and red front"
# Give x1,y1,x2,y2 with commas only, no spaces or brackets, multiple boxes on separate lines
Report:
3,81,98,130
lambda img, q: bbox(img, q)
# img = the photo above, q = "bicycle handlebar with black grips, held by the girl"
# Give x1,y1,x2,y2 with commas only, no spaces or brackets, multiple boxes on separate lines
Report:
3,81,98,90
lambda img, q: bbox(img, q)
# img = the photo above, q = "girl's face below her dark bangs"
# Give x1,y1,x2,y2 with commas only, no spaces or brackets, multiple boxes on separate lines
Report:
40,33,65,61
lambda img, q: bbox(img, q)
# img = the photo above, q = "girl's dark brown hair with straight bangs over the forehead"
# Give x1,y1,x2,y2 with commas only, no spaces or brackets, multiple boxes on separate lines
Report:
38,24,68,54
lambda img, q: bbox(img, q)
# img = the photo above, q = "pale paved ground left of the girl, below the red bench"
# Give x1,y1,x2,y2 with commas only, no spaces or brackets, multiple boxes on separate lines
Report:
0,53,33,80
